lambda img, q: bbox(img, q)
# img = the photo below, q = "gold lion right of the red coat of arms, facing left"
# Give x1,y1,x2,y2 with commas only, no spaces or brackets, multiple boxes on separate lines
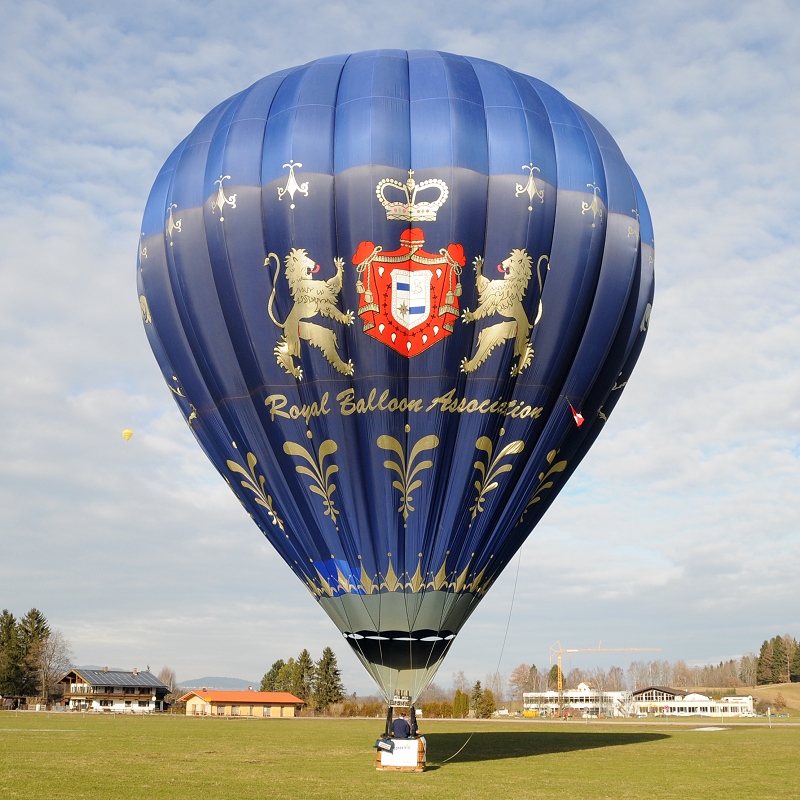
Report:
461,249,550,375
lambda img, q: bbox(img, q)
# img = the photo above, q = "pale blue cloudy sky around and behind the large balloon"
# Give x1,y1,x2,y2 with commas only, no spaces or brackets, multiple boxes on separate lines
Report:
0,0,800,692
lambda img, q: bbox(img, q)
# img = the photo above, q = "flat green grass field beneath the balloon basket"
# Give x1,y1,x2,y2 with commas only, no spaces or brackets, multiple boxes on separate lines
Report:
0,712,800,800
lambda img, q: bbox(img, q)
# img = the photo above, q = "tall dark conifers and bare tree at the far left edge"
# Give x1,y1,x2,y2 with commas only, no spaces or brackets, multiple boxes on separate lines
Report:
0,608,73,702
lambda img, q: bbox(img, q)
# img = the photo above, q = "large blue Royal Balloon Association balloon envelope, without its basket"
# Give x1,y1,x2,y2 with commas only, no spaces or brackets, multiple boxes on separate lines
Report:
138,50,654,705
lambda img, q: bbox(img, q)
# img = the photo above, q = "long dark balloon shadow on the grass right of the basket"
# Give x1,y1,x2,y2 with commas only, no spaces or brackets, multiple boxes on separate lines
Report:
425,731,670,767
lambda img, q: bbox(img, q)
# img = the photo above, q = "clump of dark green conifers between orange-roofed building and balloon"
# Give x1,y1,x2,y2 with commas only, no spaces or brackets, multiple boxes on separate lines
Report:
261,647,345,711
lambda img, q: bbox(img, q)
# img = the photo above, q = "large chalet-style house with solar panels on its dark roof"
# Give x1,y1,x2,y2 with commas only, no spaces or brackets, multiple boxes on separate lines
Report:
59,667,169,714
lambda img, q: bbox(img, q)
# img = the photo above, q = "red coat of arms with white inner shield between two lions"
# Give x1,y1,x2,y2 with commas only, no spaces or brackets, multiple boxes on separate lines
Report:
353,228,466,358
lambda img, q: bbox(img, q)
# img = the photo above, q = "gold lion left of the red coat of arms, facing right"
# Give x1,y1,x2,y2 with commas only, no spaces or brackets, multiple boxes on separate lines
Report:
264,247,354,380
